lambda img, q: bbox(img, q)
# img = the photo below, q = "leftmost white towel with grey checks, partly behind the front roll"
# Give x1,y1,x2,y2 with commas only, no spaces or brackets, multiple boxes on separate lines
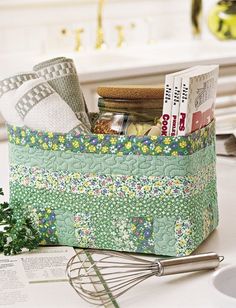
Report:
0,72,38,127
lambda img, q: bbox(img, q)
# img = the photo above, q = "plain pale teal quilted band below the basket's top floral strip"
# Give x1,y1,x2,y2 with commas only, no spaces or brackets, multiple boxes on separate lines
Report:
9,144,215,177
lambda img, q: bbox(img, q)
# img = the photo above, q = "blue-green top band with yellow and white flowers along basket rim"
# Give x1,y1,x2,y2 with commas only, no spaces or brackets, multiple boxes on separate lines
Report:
8,122,215,156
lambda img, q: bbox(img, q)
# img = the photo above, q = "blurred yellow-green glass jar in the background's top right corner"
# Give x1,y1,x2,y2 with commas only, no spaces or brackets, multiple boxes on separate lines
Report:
208,0,236,40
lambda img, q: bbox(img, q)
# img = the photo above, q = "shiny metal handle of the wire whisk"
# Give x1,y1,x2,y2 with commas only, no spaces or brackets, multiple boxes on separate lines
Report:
156,252,224,276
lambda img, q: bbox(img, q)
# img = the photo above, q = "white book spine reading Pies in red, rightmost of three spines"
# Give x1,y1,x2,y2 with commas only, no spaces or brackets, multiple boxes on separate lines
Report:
177,78,189,136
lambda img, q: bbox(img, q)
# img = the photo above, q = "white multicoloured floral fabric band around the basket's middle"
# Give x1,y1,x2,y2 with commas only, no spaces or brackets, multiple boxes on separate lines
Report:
10,164,215,199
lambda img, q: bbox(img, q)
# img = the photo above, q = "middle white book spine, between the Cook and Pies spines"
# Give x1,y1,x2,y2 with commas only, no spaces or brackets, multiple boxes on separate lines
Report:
170,77,182,136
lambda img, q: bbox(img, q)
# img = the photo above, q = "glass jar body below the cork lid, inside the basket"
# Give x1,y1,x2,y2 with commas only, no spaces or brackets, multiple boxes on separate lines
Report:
93,97,163,136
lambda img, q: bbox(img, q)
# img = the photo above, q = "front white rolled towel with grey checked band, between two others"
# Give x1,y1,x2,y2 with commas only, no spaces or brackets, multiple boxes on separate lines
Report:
15,78,90,134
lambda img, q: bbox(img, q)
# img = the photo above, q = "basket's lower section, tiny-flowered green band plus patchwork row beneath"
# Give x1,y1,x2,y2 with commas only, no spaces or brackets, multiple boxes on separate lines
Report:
11,183,218,255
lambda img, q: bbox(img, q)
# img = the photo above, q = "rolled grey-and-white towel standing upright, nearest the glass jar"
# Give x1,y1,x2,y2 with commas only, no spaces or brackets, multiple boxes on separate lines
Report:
33,57,91,129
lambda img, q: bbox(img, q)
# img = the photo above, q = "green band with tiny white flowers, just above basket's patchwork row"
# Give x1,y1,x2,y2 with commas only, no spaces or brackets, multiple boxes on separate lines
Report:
10,180,217,219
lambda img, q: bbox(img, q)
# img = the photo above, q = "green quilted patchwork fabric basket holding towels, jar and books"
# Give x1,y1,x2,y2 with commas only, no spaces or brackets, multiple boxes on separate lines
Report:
8,122,218,256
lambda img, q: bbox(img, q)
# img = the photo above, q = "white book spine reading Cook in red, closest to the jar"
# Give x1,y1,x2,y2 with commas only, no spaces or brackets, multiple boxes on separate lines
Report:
161,75,174,136
